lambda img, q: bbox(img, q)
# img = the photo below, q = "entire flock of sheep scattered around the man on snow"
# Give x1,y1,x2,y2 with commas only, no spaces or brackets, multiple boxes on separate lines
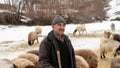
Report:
0,25,120,68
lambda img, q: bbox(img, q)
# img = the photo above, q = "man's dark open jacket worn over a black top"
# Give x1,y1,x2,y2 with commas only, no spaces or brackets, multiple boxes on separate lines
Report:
39,31,76,68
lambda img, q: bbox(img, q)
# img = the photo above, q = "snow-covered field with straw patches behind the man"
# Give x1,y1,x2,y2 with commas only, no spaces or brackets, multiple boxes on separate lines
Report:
0,21,120,59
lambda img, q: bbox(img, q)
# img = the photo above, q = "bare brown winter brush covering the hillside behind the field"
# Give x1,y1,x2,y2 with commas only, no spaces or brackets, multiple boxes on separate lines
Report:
0,0,109,25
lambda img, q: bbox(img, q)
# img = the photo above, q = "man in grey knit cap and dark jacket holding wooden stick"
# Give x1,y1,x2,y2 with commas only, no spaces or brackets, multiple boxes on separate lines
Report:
39,15,76,68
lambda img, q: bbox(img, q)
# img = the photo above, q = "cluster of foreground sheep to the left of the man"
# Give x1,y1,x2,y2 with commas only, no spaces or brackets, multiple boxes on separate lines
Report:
0,49,40,68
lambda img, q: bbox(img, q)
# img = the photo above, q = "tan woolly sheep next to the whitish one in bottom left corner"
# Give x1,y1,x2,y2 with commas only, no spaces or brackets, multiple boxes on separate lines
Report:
12,58,35,68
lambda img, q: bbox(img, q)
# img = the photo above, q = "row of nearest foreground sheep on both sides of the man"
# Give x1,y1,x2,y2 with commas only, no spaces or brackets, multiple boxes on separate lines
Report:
0,49,98,68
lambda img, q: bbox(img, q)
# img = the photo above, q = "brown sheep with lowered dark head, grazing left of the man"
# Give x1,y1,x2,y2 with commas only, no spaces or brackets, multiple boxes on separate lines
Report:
28,31,39,46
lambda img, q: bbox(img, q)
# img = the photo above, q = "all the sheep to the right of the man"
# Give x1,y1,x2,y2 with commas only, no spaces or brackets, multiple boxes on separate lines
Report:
73,23,120,68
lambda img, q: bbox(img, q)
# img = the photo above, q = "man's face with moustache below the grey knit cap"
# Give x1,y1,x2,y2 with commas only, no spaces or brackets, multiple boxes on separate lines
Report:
52,23,65,36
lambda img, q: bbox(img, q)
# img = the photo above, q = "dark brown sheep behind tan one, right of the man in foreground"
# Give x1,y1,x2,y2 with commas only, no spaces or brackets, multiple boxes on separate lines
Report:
75,49,98,68
